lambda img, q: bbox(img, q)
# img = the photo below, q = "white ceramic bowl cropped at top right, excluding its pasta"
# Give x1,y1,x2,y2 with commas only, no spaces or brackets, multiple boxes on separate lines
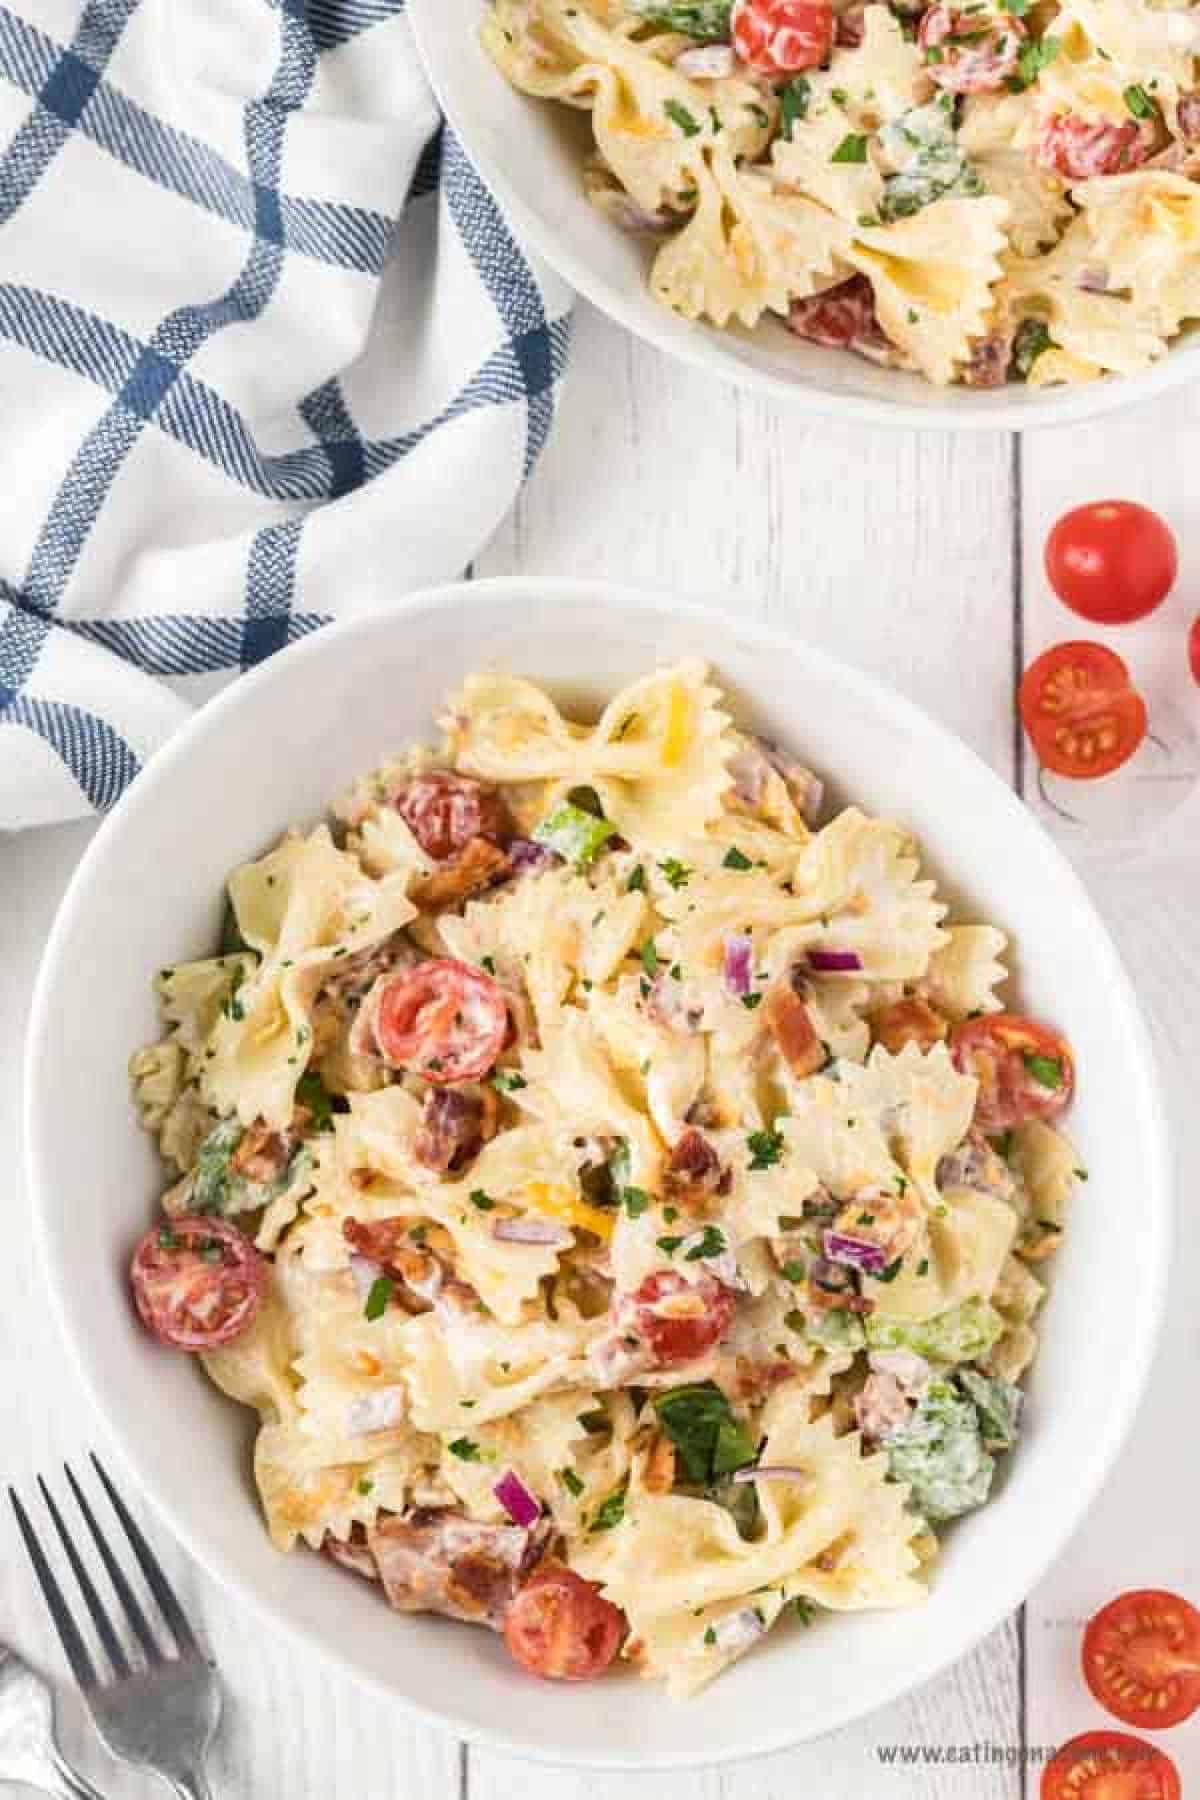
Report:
408,0,1200,430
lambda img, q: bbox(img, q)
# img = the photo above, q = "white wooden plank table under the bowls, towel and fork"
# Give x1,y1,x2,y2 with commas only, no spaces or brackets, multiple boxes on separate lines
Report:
0,308,1200,1800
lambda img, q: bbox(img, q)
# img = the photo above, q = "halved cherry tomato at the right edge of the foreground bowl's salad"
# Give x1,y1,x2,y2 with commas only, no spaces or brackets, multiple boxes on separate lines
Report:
950,1013,1076,1136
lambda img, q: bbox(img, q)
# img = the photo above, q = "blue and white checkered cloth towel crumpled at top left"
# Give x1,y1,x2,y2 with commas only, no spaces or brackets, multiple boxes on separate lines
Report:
0,0,569,828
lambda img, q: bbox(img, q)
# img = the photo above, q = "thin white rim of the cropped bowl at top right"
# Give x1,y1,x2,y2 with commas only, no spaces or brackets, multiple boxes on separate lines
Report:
407,0,1200,432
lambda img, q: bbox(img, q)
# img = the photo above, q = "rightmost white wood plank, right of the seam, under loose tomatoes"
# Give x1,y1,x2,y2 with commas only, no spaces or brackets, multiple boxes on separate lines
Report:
1022,387,1200,1793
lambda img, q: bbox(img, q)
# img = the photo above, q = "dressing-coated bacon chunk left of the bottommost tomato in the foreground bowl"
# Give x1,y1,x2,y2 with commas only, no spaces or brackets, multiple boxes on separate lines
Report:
367,1508,543,1631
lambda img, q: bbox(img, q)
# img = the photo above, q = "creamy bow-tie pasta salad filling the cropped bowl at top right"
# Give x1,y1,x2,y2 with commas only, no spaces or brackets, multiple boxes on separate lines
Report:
482,0,1200,387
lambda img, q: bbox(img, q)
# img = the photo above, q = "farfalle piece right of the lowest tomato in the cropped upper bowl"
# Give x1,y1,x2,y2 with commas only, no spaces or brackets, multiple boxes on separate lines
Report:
846,194,1009,387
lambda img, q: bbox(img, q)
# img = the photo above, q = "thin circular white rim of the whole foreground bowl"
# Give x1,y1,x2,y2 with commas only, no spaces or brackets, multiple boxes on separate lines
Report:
22,576,1173,1771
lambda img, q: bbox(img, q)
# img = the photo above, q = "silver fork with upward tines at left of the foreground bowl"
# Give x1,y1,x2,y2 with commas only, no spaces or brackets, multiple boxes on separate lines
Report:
9,1456,221,1800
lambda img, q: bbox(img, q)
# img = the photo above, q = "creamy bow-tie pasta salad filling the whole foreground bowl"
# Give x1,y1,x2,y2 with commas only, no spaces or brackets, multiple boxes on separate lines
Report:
131,661,1081,1696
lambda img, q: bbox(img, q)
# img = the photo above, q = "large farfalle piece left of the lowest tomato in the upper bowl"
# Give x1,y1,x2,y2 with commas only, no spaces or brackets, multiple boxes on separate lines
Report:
649,151,847,326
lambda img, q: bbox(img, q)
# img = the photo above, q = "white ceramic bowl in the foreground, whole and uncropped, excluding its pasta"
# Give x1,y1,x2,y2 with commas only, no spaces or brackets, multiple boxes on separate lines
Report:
27,580,1169,1768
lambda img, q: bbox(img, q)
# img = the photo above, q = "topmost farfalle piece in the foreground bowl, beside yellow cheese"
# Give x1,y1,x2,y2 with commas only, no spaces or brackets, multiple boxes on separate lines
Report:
446,659,732,850
